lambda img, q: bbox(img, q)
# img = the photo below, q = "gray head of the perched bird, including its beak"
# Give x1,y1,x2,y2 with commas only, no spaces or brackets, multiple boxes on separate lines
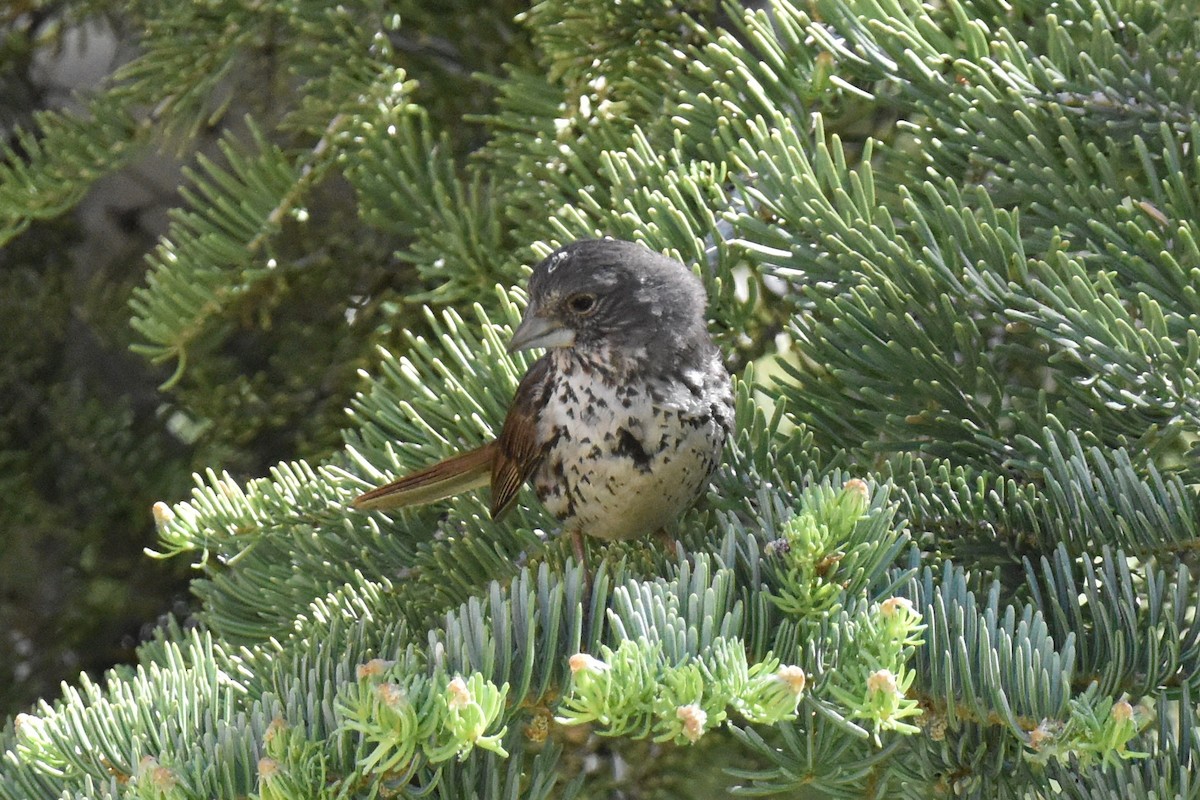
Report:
509,239,710,361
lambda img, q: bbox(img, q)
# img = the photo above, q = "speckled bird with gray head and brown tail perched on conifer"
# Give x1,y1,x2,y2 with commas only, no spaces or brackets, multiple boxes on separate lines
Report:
352,237,733,563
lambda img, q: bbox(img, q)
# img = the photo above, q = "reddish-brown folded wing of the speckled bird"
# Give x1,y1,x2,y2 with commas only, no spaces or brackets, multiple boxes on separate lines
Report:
492,356,550,519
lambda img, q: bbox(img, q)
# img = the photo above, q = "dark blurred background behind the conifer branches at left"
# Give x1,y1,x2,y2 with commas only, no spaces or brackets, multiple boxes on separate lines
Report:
0,1,532,717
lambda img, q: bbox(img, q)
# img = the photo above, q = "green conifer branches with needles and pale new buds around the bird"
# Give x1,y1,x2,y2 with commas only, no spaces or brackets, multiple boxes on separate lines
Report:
0,0,1200,798
